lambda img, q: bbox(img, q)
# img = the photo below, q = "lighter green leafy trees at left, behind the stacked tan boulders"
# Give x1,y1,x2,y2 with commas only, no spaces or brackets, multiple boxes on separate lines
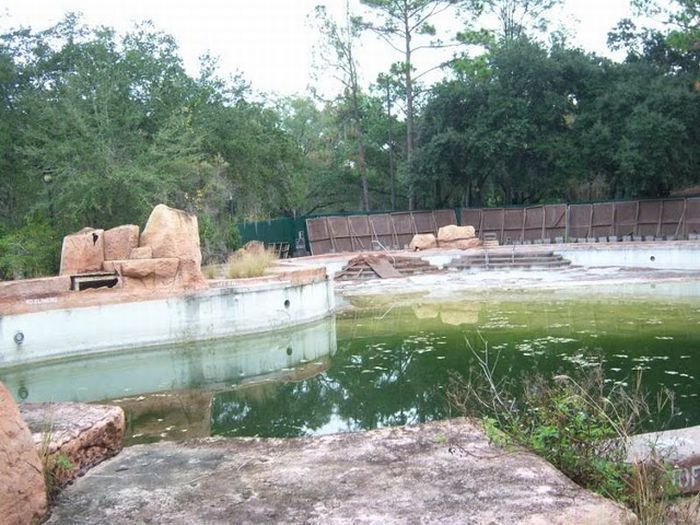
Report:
0,15,312,276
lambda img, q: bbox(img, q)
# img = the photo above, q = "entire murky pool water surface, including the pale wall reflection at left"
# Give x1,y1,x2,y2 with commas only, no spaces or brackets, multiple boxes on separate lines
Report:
0,280,700,443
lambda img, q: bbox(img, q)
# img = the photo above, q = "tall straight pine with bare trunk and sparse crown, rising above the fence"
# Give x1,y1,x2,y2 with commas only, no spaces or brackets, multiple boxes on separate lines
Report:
361,0,464,209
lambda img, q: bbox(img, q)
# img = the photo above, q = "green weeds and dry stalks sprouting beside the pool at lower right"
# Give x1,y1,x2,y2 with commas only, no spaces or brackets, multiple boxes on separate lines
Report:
447,341,696,523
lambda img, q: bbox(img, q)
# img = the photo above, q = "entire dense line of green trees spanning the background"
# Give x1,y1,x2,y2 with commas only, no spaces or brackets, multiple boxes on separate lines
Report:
0,0,700,278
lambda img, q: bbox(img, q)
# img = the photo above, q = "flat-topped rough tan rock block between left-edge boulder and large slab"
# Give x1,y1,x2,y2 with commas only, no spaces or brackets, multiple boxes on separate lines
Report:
20,403,125,489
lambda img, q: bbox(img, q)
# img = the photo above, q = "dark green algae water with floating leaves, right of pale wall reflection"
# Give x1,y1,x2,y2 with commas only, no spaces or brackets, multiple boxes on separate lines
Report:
212,293,700,437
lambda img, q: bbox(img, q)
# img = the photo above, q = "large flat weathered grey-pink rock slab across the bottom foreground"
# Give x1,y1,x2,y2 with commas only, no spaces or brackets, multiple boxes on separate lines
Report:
43,419,636,525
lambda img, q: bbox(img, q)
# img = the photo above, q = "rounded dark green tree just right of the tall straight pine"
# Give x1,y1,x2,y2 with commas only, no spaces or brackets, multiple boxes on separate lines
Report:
418,38,575,206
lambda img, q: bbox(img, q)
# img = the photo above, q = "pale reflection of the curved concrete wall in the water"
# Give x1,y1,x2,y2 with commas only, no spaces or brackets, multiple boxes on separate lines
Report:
0,317,336,402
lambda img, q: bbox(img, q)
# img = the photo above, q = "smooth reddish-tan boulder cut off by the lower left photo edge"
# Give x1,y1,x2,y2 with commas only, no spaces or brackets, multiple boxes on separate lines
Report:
0,383,47,524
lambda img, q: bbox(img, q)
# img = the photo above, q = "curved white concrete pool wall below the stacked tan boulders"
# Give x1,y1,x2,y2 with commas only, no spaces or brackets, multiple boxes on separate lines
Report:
0,268,335,367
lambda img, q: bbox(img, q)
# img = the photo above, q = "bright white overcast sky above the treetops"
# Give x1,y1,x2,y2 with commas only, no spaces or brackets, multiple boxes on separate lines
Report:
0,0,644,95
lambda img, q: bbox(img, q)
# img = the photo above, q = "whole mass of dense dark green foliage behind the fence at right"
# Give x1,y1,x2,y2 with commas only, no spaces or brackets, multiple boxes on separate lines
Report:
416,39,700,207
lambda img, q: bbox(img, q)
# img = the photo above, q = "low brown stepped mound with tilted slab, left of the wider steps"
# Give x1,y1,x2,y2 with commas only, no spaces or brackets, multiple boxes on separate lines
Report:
335,254,440,281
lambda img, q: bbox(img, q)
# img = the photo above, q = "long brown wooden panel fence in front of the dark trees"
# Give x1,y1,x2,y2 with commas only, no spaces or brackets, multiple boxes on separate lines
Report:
306,198,700,255
